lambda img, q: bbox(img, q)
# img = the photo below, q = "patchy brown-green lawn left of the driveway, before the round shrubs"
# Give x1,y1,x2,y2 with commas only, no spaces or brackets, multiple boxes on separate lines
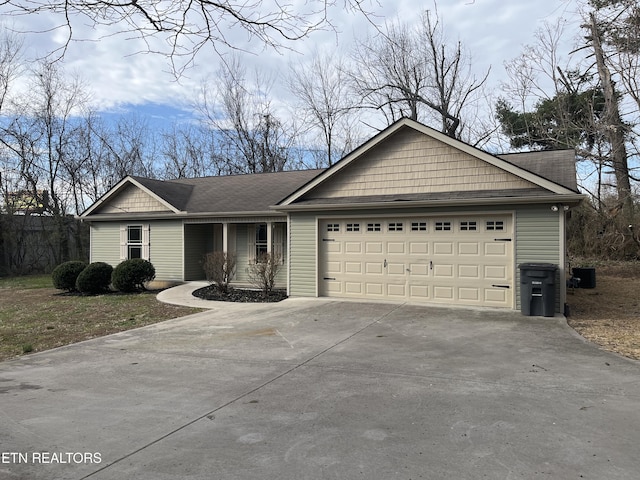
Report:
0,275,200,360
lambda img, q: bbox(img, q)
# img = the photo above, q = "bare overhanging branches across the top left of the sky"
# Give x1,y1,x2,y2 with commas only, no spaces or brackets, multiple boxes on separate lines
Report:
0,0,370,74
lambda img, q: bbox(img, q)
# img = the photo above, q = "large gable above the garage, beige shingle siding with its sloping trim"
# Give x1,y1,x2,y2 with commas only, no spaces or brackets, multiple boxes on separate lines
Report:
280,119,576,206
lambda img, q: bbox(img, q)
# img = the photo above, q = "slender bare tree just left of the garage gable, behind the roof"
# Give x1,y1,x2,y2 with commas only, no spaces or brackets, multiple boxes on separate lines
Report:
287,52,359,167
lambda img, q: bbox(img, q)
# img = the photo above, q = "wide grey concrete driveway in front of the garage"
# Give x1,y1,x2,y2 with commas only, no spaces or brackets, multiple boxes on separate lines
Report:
0,299,640,480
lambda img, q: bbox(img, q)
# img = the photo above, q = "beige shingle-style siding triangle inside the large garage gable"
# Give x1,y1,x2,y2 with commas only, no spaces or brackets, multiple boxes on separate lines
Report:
313,129,535,198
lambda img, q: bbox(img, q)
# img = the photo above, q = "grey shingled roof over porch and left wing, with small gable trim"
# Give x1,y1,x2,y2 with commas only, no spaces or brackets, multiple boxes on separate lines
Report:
81,170,322,218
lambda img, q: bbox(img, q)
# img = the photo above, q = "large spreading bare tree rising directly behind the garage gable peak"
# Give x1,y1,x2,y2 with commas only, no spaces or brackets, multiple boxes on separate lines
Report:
351,7,489,138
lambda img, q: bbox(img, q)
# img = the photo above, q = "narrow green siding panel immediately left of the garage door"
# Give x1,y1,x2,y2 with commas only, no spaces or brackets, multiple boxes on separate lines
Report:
289,214,317,297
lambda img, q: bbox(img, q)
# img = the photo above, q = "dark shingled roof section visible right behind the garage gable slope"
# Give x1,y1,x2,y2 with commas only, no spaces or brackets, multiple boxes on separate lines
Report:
497,149,578,192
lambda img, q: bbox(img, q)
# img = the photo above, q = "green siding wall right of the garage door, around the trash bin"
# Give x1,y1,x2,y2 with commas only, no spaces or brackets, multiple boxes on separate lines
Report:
515,205,564,312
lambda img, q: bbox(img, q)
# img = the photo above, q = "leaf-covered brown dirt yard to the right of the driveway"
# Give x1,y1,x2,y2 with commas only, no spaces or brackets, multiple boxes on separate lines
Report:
567,262,640,360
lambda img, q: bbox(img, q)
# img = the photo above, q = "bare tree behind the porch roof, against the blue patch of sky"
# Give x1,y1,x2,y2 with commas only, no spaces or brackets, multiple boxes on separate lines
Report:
197,56,302,174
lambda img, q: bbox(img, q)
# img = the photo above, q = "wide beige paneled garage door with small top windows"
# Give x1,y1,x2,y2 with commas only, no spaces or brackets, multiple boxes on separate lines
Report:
319,215,514,307
